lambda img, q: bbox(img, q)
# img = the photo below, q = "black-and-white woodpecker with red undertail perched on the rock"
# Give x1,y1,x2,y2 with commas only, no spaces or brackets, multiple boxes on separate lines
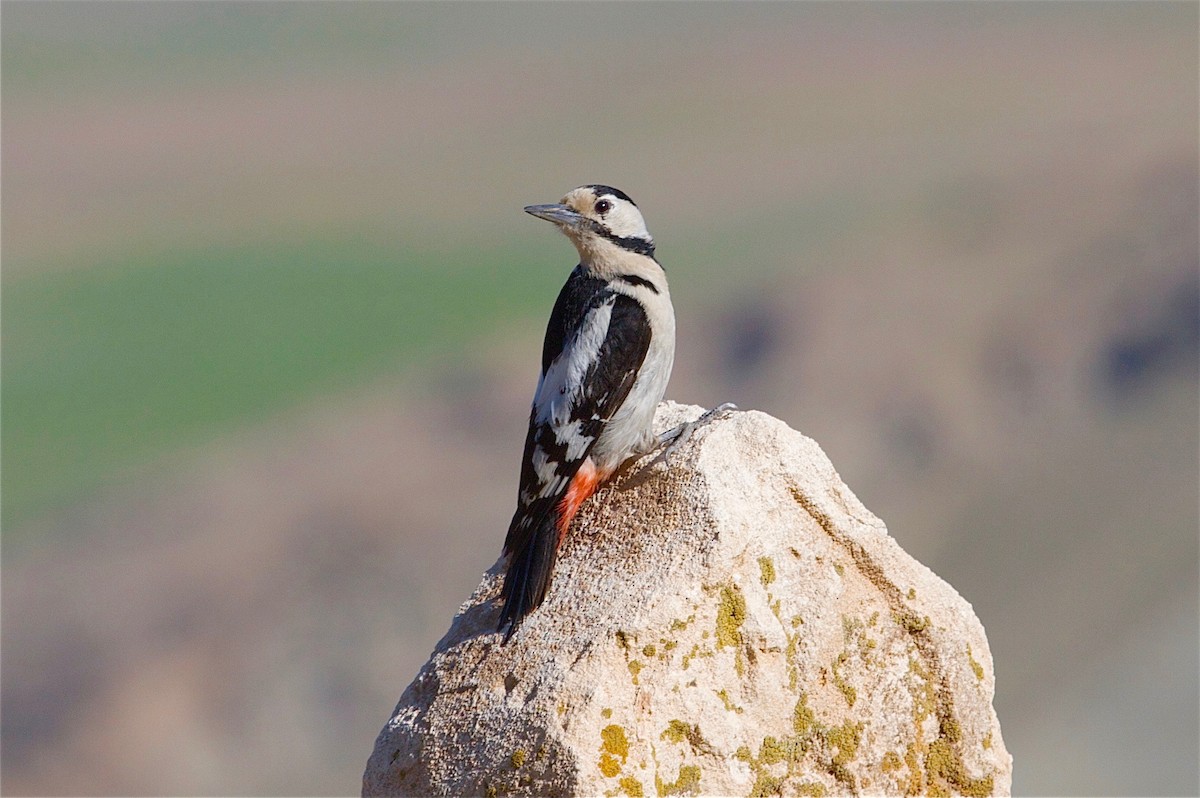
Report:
499,185,686,642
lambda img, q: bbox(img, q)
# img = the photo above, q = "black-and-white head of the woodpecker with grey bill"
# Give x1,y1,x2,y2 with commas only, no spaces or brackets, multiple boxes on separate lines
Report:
526,185,654,263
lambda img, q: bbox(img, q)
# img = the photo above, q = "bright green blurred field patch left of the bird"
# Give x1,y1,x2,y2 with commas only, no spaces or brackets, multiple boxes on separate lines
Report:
2,240,562,529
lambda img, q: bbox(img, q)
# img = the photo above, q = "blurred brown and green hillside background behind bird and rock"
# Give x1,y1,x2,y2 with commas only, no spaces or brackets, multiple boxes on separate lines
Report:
0,0,1200,794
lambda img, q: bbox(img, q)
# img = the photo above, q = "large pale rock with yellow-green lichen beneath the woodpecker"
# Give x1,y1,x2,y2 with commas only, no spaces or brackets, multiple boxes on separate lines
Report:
362,403,1012,796
